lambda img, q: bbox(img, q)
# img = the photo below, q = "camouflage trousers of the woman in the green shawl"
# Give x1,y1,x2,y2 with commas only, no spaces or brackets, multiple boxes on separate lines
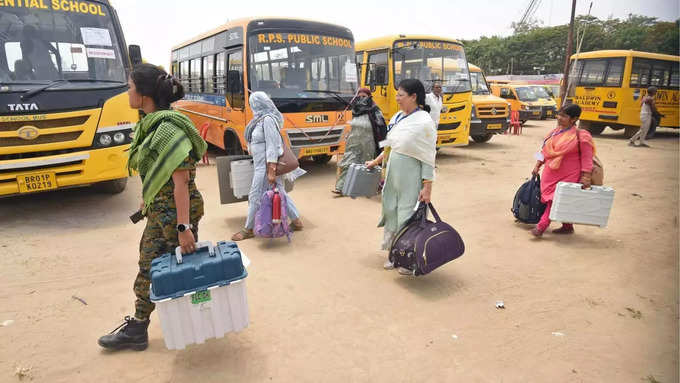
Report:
133,196,203,320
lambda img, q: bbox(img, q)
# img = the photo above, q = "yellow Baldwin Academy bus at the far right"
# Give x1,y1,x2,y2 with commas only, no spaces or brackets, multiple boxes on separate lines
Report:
566,50,680,137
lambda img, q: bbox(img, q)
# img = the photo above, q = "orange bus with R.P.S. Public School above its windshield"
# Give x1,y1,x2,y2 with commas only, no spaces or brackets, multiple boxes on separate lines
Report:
171,18,357,163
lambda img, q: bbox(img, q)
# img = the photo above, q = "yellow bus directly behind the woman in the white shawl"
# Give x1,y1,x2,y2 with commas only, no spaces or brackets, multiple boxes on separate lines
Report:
356,35,472,147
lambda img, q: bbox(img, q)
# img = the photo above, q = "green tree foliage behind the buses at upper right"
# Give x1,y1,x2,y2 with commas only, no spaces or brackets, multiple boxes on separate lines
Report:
463,14,680,75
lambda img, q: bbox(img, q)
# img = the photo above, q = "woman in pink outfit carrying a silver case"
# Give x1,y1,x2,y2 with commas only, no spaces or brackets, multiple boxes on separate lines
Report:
531,104,595,237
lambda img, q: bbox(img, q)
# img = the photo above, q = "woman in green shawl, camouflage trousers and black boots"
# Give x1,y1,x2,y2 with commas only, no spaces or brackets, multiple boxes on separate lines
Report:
99,64,207,351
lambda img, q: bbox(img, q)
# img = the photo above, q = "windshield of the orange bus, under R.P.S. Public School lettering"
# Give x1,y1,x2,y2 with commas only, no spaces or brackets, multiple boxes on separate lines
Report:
248,31,357,99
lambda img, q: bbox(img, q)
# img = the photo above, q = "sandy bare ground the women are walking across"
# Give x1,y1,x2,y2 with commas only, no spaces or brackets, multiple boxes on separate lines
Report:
0,122,678,383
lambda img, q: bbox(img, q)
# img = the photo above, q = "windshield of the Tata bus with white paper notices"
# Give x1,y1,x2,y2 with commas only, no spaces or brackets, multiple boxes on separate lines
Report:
0,1,126,89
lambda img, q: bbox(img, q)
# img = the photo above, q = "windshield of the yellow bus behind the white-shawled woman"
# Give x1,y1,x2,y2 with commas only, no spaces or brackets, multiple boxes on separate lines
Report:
394,41,471,93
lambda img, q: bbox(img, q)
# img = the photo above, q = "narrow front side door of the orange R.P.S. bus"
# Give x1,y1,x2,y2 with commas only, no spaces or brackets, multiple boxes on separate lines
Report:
223,47,246,154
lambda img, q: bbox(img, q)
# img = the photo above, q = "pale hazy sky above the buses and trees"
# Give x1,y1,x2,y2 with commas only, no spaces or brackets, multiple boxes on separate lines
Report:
111,0,680,68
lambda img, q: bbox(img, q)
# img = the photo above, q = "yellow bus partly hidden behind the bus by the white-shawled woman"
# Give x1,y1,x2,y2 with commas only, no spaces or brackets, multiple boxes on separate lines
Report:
468,63,510,142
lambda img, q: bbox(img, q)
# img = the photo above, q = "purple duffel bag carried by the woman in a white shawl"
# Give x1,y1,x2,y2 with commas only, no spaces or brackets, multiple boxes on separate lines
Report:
389,203,465,275
